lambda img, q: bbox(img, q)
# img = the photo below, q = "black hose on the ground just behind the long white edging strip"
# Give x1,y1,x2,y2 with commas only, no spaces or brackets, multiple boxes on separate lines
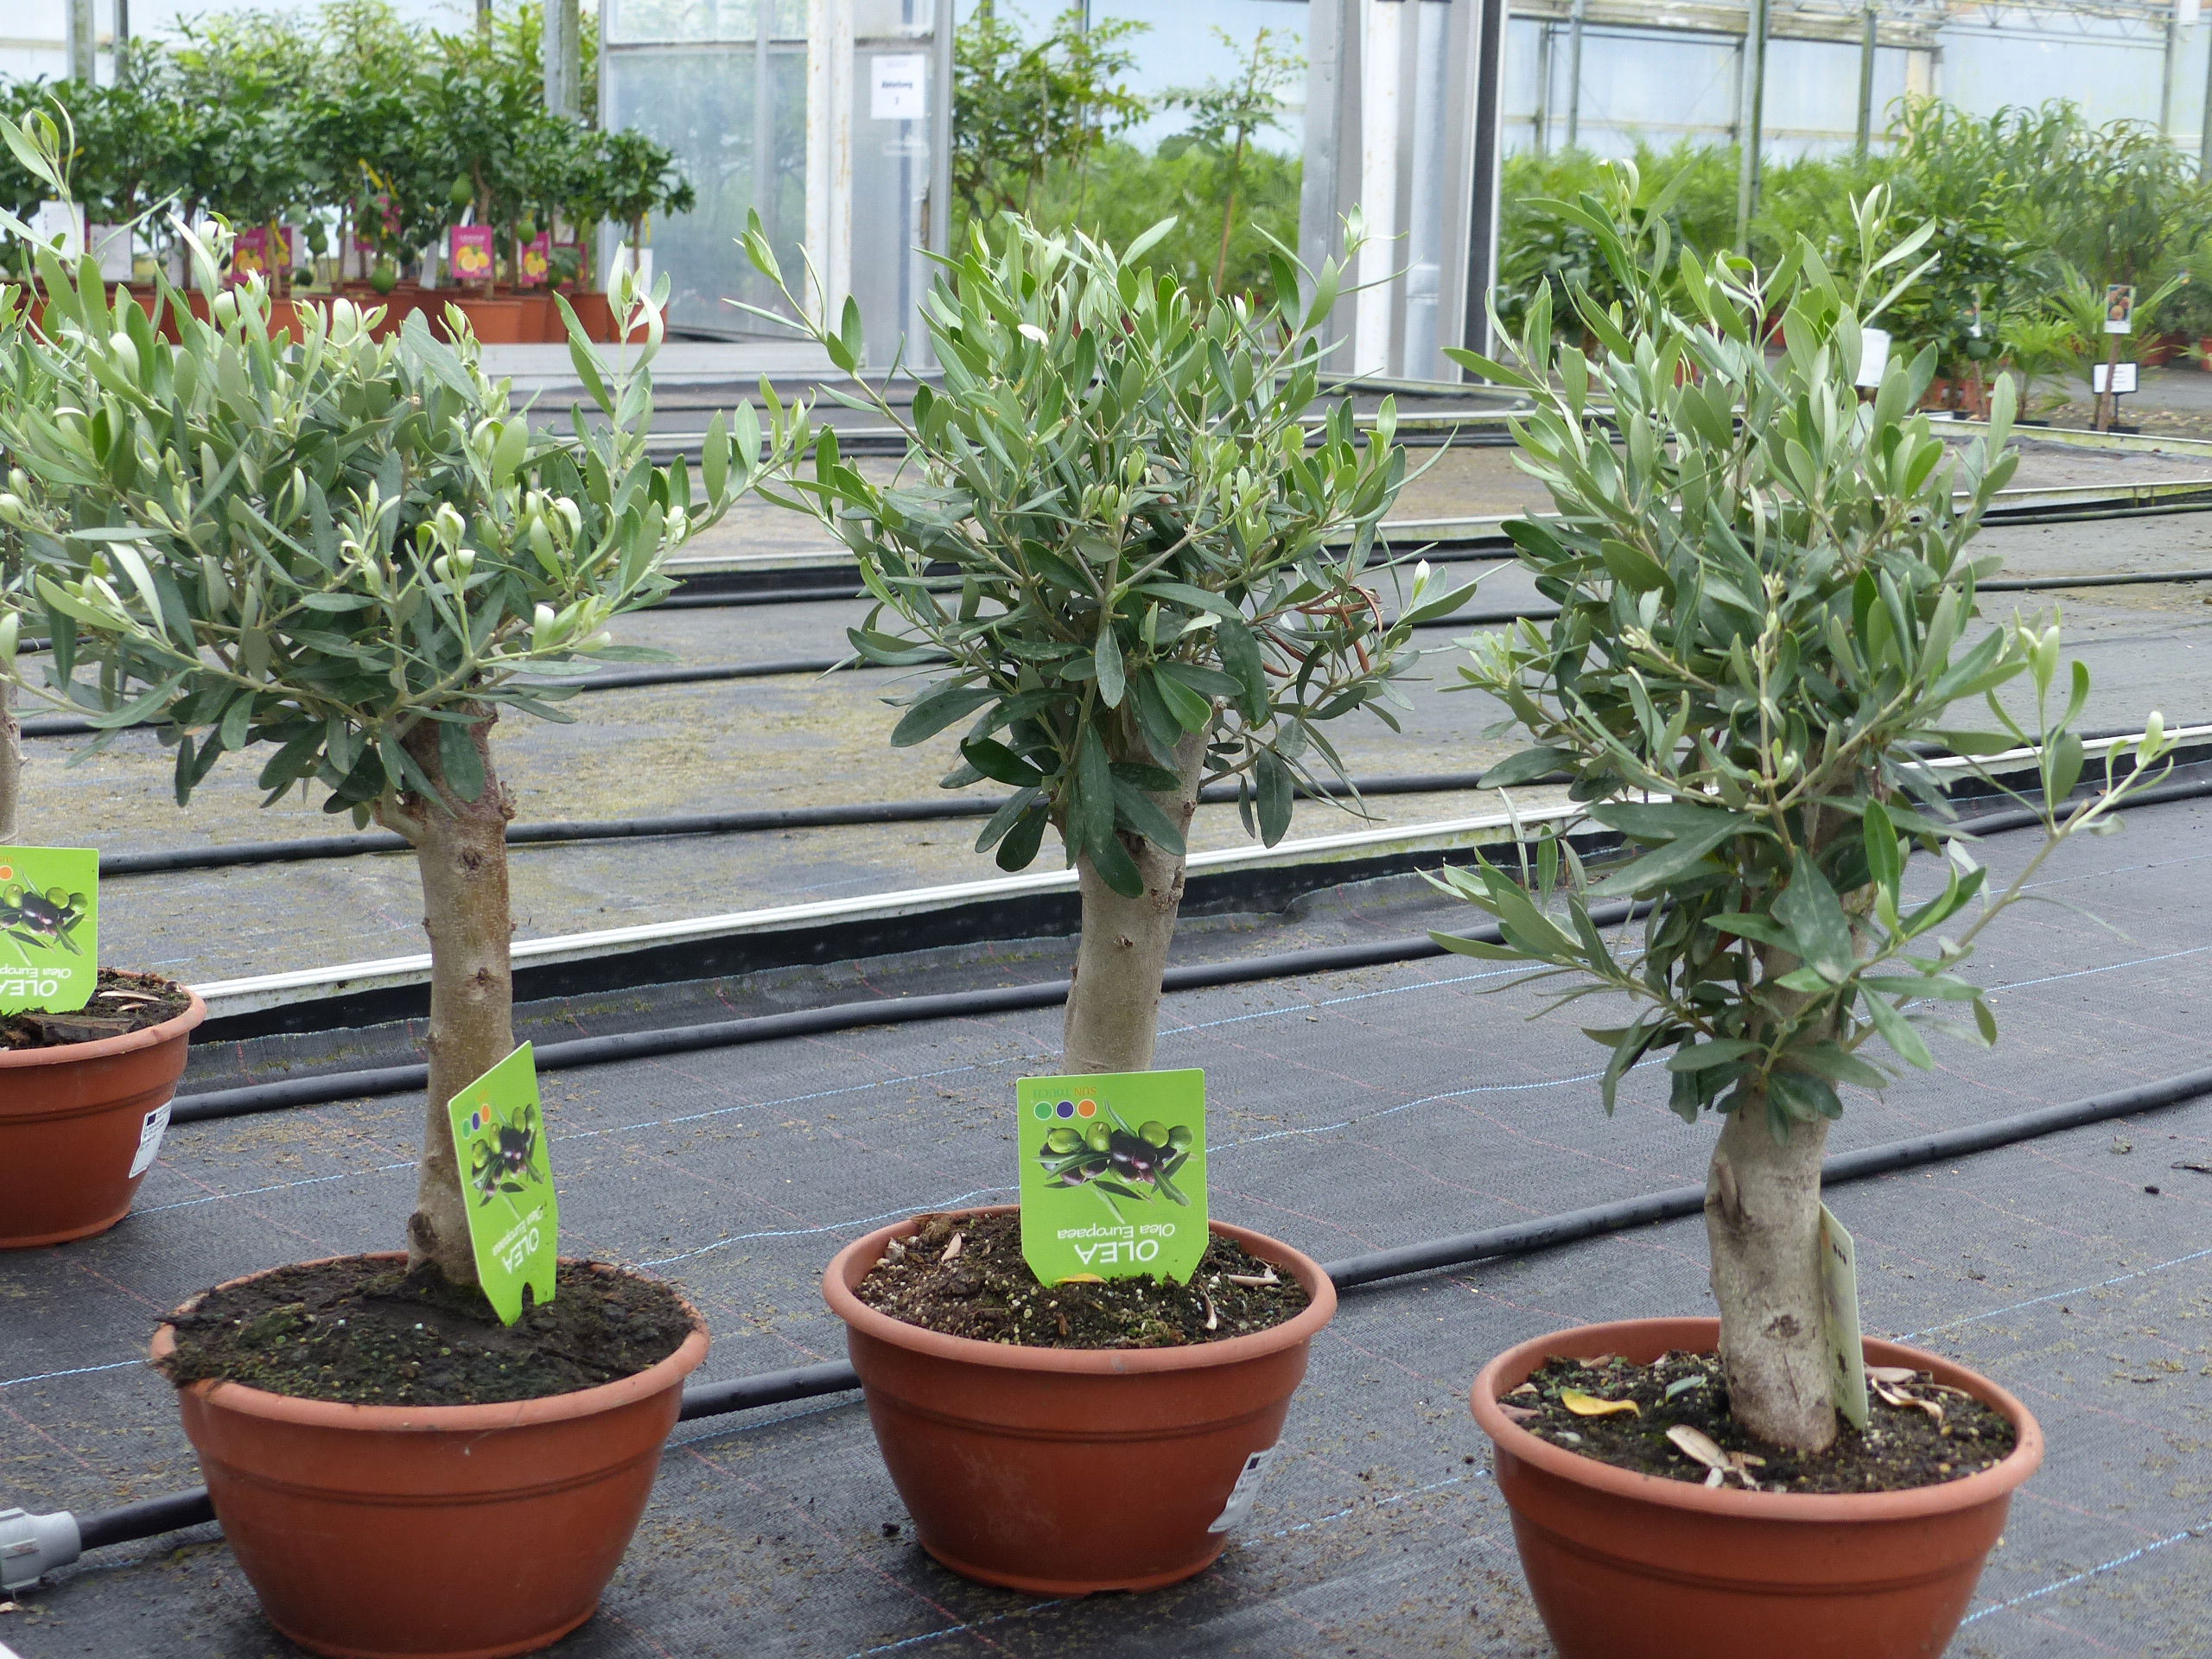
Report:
99,772,1482,878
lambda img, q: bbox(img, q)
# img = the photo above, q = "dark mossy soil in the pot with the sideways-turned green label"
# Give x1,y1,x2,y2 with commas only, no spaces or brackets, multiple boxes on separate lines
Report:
162,1256,690,1405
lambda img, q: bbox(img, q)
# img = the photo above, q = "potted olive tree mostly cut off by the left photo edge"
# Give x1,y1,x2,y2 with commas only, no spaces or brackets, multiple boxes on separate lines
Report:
0,111,206,1249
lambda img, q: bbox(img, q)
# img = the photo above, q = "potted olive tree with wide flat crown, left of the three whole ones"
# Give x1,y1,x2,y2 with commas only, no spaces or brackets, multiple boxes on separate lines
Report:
0,245,796,1655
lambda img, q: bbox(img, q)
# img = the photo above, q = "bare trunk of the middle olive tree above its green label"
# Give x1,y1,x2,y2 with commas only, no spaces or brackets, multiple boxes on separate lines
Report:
1062,732,1205,1073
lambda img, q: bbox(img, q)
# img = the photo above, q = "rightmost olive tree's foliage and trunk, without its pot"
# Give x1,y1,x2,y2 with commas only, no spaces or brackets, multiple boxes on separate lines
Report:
1438,168,2170,1453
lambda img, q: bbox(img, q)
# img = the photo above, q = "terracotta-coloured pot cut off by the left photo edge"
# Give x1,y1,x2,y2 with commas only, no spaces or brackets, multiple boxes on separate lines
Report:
0,995,208,1249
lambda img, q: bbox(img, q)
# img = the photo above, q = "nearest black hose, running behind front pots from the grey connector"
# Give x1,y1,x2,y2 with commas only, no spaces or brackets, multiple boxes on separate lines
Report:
78,1071,2212,1548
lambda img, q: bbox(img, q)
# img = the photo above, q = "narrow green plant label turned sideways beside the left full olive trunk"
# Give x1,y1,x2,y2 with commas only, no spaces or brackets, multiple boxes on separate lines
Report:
447,1044,560,1325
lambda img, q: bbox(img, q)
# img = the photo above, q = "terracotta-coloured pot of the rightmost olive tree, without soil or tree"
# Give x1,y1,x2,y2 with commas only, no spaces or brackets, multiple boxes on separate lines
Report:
1473,1319,2044,1659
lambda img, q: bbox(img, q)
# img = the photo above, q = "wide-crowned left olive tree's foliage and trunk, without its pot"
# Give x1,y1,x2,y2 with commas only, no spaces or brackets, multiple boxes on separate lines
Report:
0,231,796,1285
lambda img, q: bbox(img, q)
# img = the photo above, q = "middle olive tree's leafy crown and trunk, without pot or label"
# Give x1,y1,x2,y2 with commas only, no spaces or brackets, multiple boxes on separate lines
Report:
746,214,1466,1071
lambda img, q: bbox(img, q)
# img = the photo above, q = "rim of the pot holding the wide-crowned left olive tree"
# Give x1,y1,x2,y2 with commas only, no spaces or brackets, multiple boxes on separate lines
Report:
149,1249,710,1433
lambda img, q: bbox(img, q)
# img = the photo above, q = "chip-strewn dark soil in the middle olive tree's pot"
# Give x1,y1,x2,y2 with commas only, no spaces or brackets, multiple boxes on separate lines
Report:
854,1212,1310,1347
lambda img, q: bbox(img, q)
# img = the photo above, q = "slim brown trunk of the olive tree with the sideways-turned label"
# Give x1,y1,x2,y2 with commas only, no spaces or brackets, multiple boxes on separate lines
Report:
378,715,515,1285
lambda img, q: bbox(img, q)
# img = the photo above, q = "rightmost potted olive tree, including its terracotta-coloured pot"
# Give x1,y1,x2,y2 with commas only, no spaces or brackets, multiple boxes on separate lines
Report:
1440,168,2170,1656
